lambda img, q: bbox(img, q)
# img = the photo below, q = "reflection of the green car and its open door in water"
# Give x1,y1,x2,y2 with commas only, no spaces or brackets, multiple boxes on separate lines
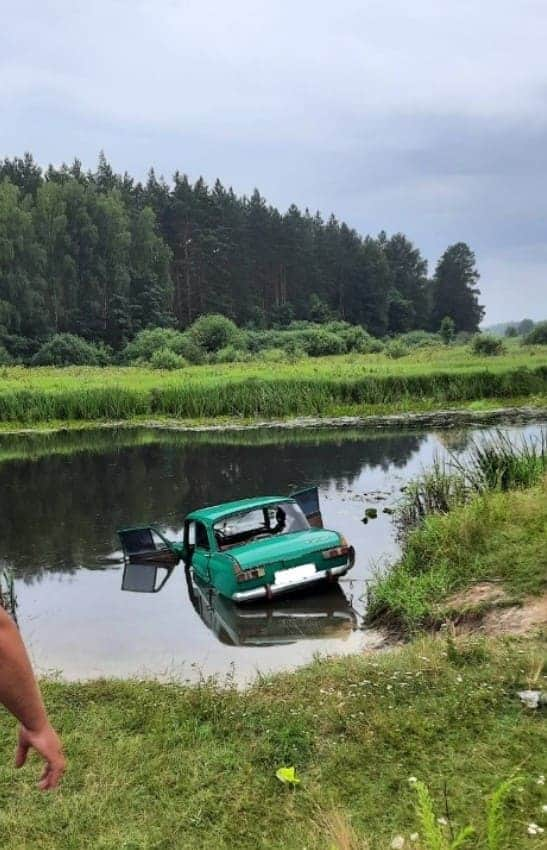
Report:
122,561,359,646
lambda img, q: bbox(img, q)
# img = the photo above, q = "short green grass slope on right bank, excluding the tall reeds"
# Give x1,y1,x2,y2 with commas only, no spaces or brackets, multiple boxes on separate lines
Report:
368,477,547,631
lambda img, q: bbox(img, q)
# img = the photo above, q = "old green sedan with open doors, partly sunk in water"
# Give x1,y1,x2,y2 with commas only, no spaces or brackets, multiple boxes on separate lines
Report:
119,488,355,602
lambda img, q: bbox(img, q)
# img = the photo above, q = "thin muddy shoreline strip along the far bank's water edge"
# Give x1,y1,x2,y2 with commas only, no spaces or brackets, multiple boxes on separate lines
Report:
0,406,547,438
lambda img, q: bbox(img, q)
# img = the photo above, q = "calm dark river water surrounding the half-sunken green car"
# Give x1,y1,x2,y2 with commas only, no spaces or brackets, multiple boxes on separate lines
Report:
0,425,540,680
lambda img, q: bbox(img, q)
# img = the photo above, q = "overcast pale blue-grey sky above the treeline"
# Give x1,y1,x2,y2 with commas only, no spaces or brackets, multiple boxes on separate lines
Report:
0,0,547,323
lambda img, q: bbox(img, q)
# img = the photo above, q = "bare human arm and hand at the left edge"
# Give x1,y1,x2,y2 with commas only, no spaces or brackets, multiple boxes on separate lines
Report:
0,606,65,791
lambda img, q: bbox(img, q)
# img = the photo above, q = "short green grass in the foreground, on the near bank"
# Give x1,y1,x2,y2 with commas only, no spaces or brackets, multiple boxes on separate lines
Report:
0,638,547,850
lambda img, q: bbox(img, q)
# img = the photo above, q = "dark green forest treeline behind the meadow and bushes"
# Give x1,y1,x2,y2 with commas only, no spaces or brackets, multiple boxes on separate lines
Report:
0,154,484,357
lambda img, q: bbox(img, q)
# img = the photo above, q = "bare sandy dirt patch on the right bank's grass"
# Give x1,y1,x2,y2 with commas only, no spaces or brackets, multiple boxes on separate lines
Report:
444,581,547,635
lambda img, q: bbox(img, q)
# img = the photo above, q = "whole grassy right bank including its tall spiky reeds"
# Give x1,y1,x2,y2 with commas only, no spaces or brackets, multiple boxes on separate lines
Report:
368,440,547,632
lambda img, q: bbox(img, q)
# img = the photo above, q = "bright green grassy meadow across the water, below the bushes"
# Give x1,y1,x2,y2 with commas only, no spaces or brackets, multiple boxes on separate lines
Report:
0,346,547,425
